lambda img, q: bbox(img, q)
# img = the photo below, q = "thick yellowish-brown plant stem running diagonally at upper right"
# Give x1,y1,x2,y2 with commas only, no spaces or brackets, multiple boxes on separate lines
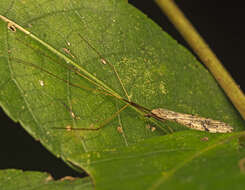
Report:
156,0,245,119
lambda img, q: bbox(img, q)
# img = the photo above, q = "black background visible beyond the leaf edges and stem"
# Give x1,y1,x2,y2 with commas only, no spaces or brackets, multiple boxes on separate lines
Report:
0,0,245,179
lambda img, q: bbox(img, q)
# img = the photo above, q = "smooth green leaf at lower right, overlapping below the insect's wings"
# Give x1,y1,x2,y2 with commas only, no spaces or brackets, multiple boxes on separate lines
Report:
70,131,245,190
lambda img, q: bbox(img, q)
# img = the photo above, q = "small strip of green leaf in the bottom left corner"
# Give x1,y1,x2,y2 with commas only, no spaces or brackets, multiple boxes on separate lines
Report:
0,169,93,190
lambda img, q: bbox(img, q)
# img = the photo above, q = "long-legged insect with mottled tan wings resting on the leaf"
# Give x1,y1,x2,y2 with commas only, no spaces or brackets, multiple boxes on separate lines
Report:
4,17,233,133
